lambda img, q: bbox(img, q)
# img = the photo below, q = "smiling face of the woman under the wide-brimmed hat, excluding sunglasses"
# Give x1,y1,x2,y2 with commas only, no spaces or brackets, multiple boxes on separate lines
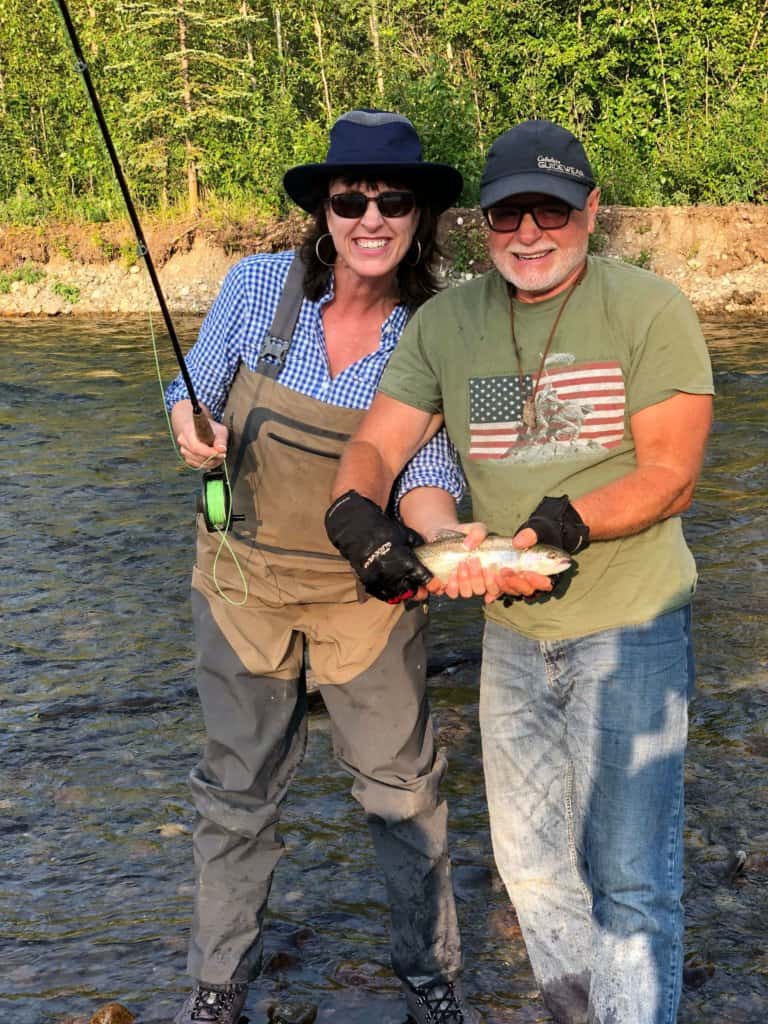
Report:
326,178,419,280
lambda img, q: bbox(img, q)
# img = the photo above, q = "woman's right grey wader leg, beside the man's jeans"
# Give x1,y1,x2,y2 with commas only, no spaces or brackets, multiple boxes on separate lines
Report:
321,608,461,985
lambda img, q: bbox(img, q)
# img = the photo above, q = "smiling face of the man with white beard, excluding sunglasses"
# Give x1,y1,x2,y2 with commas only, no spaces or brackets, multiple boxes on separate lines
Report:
488,188,600,302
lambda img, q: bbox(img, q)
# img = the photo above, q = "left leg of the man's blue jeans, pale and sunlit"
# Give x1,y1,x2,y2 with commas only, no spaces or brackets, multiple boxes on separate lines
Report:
480,622,592,1024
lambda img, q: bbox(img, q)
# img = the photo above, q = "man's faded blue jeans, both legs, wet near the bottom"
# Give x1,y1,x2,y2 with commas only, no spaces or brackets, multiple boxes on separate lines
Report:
480,607,693,1024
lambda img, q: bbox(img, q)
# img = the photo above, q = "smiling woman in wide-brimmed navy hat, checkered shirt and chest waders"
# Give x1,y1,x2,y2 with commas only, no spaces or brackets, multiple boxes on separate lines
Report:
168,111,479,1024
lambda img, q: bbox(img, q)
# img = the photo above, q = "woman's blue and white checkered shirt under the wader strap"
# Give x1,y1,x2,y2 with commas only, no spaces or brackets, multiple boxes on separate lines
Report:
166,252,464,501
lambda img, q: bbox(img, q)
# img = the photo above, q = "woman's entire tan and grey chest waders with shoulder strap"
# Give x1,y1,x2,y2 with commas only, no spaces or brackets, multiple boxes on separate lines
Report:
188,257,461,999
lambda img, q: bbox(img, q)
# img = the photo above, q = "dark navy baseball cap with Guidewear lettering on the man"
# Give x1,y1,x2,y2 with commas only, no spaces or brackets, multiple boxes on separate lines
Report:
480,120,595,210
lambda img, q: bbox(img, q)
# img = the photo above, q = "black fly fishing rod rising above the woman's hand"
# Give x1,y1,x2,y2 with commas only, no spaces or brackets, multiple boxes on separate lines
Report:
55,0,214,448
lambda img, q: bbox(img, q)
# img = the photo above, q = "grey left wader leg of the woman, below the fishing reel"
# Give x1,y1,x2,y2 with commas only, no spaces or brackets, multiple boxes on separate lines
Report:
187,591,307,984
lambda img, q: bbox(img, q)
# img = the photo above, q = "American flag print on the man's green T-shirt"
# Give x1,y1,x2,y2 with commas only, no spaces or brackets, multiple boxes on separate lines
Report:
469,353,626,462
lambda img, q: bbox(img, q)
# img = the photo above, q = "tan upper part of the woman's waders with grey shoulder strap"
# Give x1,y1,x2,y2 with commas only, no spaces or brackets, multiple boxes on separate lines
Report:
193,258,403,683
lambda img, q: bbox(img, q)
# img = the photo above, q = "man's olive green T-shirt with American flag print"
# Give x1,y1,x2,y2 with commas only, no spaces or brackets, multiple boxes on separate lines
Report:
380,257,714,640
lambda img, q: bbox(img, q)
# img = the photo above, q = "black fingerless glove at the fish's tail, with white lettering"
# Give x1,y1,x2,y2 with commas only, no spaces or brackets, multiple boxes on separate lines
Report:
326,490,432,604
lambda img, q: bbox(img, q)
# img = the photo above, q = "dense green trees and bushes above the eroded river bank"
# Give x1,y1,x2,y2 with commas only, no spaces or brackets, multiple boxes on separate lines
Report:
0,0,768,221
